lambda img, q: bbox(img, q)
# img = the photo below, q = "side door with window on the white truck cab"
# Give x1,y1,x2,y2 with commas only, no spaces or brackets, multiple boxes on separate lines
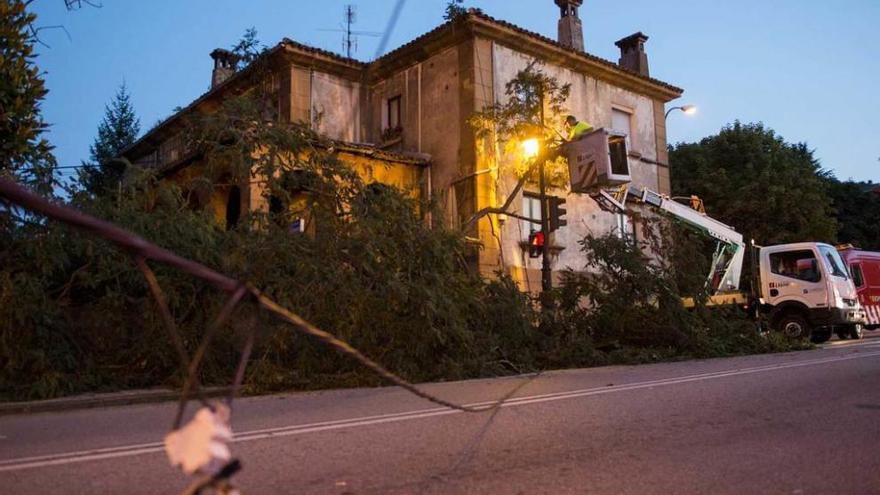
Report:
762,248,828,308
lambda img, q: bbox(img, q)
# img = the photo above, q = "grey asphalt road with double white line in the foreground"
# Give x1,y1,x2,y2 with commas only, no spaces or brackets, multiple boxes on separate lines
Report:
0,332,880,494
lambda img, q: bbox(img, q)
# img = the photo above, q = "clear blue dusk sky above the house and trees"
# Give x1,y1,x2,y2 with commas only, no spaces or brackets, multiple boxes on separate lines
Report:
33,0,880,181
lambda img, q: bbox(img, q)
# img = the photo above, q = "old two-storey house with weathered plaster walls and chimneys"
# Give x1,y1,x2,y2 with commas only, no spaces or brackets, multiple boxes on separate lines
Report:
125,0,683,290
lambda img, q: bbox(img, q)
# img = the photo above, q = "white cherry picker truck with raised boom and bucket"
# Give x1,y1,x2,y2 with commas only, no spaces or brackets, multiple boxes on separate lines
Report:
562,129,867,343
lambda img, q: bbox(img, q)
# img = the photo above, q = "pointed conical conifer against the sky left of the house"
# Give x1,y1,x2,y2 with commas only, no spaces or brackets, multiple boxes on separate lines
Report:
78,82,141,194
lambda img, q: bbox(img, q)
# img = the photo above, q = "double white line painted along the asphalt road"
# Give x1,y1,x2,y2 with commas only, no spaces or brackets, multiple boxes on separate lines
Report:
0,352,880,472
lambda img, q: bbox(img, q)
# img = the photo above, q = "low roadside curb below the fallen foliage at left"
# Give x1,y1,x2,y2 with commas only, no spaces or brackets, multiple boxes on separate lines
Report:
0,387,229,416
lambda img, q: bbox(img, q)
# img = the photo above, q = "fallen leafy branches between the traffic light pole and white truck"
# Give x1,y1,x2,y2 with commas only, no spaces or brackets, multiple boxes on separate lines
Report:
544,223,805,366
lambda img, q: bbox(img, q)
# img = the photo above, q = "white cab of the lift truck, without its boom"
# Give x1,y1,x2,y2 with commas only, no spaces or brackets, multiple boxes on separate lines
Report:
759,242,867,343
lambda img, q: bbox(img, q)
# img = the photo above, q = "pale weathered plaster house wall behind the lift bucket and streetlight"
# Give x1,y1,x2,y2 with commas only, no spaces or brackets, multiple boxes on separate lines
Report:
481,43,668,290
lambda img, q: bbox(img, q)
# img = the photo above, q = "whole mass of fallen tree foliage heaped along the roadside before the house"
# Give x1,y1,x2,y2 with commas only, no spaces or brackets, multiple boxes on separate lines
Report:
0,88,804,399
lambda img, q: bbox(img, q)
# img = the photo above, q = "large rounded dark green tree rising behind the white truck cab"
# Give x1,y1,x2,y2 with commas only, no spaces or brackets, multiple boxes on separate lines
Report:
669,122,837,245
